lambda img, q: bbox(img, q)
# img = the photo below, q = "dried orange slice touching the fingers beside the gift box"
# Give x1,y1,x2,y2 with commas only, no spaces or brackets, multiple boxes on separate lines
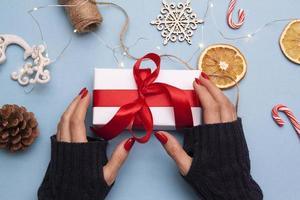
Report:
198,44,247,89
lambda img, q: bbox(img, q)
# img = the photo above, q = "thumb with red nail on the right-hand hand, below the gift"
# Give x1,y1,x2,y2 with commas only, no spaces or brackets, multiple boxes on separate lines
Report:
154,131,193,176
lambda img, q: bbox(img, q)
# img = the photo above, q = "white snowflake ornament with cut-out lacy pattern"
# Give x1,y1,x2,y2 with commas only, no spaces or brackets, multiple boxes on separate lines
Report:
151,0,204,45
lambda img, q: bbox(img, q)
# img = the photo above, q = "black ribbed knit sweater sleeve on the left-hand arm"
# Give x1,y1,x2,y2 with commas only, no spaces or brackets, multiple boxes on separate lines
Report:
38,136,110,200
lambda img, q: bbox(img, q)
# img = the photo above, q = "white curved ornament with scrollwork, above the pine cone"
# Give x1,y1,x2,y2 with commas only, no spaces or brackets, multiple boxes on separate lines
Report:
0,35,51,86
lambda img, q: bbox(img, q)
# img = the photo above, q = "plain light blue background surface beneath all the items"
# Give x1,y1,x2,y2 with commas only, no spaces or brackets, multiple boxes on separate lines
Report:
0,0,300,200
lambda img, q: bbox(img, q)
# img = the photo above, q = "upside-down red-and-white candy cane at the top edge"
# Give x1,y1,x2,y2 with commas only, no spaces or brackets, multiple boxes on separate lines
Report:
226,0,245,29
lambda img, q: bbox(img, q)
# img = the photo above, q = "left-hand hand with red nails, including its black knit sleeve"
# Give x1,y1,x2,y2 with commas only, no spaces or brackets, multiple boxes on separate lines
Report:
38,88,135,200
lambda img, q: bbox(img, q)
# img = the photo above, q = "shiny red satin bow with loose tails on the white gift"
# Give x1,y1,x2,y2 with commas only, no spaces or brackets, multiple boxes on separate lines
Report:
92,53,197,143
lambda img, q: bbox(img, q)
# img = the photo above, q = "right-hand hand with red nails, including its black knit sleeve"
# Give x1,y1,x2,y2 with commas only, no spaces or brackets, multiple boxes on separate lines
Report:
155,73,263,200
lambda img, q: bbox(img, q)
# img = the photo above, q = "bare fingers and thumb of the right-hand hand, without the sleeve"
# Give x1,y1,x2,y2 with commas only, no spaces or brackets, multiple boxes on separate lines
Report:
155,73,237,175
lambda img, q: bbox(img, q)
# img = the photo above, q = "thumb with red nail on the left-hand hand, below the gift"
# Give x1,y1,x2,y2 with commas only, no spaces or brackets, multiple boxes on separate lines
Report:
103,138,135,186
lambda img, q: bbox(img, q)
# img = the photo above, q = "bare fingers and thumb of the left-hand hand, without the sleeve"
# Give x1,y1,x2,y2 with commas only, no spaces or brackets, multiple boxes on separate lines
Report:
56,88,135,186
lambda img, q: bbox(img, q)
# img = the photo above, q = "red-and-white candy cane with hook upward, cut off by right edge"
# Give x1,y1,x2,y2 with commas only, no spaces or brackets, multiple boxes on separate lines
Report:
272,104,300,136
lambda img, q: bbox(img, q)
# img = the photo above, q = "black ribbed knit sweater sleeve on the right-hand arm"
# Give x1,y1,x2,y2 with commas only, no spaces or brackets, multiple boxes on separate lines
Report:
180,119,263,200
